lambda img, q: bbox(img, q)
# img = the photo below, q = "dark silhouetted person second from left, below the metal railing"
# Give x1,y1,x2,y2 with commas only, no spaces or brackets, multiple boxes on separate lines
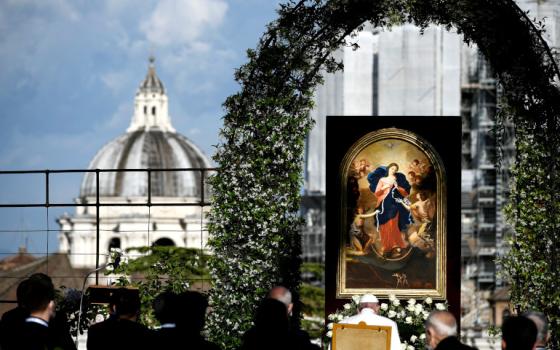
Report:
87,288,152,350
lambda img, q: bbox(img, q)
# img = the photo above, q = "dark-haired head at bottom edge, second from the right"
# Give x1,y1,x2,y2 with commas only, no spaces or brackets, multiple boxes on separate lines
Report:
502,316,537,350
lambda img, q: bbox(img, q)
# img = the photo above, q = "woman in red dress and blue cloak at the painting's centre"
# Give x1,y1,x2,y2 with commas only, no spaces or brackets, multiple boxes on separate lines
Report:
367,163,412,257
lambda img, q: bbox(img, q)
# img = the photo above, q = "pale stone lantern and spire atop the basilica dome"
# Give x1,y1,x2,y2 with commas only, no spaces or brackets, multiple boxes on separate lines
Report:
126,55,175,132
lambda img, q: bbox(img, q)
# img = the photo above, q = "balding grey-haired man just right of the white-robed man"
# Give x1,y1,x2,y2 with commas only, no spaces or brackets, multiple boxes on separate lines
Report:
424,311,475,350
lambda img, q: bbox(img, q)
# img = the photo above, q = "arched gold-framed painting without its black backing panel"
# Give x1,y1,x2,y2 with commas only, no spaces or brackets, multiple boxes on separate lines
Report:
336,128,447,299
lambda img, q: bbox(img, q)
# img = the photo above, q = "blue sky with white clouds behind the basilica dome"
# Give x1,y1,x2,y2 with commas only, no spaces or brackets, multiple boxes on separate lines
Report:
0,0,279,258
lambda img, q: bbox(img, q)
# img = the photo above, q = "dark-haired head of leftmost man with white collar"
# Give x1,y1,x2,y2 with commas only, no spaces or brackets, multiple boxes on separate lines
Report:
18,275,55,321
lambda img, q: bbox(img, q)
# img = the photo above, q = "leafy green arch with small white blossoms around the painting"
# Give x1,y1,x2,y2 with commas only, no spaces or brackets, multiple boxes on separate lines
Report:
209,0,560,349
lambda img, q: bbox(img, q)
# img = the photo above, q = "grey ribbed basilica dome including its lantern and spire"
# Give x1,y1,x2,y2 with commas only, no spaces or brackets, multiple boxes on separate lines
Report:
80,58,210,197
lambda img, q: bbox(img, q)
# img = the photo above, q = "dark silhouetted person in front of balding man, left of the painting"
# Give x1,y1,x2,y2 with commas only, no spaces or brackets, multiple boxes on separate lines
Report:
240,298,306,350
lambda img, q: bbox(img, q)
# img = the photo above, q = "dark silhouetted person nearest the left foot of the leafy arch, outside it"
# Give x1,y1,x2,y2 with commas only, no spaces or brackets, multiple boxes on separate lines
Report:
176,291,220,350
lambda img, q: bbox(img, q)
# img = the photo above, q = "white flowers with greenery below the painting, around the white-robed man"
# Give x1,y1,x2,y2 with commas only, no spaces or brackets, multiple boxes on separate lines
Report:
325,295,447,350
